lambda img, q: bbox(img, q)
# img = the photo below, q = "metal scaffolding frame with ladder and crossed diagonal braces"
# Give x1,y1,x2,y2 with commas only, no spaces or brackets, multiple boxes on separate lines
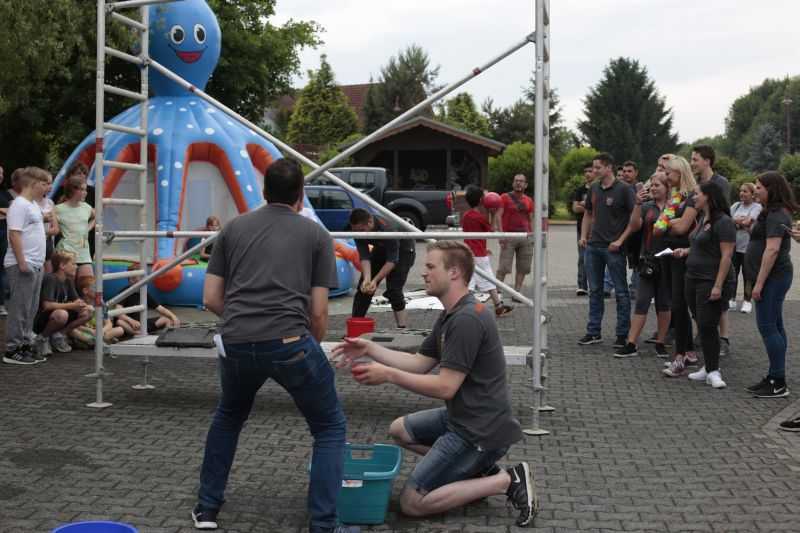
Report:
88,0,549,435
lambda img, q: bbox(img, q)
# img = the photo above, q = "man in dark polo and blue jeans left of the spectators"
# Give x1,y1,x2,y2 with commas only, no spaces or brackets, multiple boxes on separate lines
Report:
578,153,640,348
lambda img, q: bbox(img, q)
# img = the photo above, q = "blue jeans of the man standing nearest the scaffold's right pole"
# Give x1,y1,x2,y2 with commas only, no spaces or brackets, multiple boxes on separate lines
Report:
586,244,631,337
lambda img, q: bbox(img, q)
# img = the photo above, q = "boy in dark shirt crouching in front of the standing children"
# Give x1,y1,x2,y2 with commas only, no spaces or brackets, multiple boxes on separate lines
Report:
33,252,94,357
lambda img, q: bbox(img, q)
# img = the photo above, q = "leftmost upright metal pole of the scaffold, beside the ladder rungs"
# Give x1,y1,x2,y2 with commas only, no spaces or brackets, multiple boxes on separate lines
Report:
86,0,111,409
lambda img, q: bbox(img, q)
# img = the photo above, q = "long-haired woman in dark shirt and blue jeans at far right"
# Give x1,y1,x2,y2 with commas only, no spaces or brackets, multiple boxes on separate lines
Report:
744,172,797,398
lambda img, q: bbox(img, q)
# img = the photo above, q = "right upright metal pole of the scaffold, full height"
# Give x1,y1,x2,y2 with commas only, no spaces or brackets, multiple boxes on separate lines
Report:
524,0,550,436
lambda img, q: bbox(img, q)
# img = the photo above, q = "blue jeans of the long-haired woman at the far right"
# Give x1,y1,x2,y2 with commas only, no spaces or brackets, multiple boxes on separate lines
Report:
756,272,793,379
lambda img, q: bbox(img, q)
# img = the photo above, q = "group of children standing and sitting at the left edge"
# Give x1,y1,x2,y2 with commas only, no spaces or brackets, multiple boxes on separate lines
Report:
0,163,177,365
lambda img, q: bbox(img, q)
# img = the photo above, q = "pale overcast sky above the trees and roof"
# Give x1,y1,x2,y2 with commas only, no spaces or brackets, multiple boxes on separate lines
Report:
274,0,800,142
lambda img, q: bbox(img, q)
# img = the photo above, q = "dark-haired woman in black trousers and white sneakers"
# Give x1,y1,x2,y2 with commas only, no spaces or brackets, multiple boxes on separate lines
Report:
675,182,736,389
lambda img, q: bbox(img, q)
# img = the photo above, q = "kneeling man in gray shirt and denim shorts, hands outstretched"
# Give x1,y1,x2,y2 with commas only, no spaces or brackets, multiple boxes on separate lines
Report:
333,241,538,526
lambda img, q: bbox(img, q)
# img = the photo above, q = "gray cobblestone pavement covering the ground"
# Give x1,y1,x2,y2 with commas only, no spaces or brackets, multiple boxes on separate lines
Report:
0,228,800,533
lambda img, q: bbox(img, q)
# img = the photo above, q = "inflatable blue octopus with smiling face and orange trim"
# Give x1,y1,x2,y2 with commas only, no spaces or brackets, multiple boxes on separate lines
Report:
53,0,352,305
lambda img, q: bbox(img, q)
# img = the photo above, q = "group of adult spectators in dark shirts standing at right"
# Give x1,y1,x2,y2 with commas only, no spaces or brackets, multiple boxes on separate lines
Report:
573,145,800,404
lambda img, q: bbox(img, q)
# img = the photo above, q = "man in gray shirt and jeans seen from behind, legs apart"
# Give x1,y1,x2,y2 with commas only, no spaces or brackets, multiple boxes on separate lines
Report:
192,159,359,533
